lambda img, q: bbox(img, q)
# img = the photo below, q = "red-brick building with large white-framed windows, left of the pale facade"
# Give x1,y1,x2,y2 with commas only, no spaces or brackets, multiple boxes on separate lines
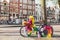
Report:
9,0,35,18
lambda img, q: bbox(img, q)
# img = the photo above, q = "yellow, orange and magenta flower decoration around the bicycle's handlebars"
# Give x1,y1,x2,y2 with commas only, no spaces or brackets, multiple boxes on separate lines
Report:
23,16,38,36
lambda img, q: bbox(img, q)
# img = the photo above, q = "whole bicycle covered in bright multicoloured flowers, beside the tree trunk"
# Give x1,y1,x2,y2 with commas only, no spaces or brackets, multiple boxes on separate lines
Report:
20,16,53,37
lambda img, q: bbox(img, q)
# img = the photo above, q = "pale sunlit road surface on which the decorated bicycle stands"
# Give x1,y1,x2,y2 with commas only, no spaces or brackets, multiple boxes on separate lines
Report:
0,25,60,40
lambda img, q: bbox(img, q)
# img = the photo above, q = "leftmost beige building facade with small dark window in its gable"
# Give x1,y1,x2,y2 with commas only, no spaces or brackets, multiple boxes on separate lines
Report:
0,0,9,22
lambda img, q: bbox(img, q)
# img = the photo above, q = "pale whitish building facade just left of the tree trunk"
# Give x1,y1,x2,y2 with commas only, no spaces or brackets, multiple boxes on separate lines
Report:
35,0,44,21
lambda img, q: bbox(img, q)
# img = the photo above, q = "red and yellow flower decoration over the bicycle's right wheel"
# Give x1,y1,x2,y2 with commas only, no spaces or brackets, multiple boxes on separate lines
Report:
41,25,53,38
